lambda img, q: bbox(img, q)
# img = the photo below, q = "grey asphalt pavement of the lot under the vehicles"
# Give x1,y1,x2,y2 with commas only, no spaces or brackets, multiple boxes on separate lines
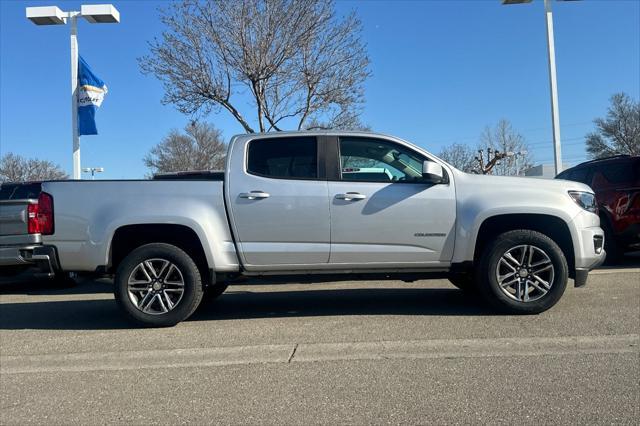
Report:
0,265,640,425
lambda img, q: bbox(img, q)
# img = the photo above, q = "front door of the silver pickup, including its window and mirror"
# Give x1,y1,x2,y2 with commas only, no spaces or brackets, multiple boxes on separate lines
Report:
329,137,456,268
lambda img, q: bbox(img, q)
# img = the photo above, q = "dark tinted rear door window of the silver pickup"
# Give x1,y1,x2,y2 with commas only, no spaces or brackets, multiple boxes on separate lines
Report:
247,137,318,179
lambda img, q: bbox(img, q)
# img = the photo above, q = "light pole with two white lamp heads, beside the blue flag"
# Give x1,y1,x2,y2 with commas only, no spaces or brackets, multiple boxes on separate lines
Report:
27,4,120,179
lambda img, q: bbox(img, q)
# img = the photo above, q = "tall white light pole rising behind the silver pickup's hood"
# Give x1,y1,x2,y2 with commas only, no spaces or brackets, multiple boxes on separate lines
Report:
502,0,577,175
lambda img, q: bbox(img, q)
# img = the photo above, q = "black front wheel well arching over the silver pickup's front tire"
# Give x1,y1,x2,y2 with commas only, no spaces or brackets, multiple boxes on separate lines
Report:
473,214,575,277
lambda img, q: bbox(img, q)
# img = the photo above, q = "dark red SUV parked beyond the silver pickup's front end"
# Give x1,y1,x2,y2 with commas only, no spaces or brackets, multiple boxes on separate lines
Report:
556,155,640,263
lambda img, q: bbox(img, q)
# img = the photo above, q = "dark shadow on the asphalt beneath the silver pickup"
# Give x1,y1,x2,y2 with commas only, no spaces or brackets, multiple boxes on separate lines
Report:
0,286,494,330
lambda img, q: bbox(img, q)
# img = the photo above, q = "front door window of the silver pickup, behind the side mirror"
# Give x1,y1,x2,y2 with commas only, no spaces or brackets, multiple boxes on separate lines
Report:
340,137,426,183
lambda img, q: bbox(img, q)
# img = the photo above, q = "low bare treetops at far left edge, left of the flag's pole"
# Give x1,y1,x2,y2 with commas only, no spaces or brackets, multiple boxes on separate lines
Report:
0,152,69,182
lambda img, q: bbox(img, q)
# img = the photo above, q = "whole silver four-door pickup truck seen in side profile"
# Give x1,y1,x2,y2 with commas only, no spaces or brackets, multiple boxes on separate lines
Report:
3,132,605,326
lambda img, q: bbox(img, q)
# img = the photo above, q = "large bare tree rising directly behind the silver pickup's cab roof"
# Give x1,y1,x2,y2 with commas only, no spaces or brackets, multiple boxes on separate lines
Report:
139,0,369,133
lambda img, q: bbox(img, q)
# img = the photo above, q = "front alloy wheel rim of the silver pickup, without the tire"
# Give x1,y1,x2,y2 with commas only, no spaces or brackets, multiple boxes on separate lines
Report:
495,244,555,303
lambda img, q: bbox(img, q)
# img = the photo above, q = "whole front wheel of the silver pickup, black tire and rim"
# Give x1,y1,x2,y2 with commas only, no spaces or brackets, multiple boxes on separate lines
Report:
476,230,569,314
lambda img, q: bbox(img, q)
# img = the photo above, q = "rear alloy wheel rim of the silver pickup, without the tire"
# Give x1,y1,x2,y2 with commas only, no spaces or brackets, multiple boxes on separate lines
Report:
127,257,185,315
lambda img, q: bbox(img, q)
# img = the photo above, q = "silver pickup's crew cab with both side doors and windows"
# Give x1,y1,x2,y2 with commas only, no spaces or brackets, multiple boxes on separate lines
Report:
225,134,456,271
